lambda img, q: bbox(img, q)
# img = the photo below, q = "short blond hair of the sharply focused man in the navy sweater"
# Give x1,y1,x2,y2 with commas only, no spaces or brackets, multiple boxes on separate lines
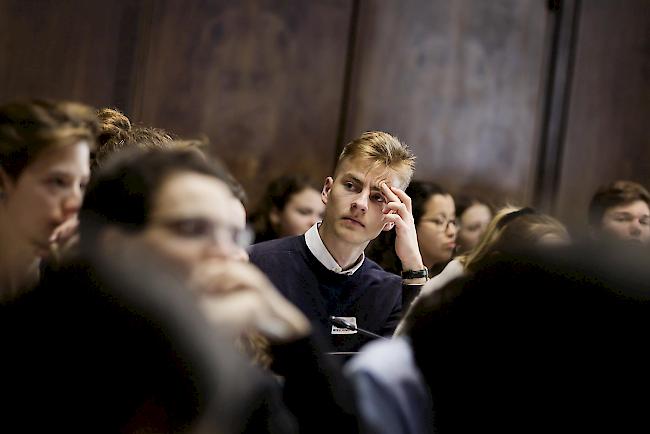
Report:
337,131,415,188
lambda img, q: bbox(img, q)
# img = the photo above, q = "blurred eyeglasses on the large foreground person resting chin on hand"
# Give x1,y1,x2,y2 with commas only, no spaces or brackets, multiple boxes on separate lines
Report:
150,218,254,249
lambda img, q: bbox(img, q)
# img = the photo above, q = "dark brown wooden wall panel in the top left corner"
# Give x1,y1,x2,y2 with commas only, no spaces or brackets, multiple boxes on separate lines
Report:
0,0,130,106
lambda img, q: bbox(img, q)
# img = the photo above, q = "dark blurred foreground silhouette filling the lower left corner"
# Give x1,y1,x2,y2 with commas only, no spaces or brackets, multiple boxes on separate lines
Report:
0,244,297,434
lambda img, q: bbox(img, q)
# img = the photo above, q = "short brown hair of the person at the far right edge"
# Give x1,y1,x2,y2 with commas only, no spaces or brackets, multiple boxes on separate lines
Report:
589,180,650,227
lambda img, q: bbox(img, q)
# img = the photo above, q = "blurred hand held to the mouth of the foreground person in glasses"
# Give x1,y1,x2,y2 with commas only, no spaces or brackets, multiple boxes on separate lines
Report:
190,261,310,343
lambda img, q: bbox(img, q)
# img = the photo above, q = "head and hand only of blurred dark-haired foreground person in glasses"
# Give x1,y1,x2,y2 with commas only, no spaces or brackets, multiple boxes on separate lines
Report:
81,150,309,350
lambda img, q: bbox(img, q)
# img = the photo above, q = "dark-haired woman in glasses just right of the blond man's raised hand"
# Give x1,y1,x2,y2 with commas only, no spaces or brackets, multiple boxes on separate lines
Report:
367,181,457,277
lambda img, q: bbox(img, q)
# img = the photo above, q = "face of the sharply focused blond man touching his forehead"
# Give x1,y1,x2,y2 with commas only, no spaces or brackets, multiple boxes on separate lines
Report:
321,159,400,247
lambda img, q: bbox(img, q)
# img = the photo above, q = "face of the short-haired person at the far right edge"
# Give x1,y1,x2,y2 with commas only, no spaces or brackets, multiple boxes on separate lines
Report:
600,200,650,243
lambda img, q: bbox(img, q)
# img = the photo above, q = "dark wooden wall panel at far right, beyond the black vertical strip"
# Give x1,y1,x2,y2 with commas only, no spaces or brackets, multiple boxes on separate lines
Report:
556,0,650,234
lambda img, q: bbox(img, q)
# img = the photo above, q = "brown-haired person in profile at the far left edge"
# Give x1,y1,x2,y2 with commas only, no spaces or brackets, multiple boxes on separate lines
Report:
0,101,98,300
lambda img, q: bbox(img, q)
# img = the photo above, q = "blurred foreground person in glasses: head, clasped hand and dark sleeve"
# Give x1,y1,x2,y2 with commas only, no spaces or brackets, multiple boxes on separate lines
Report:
80,150,356,432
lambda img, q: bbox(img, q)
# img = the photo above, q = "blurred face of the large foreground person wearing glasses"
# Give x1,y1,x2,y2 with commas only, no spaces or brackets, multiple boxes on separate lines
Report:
137,172,249,276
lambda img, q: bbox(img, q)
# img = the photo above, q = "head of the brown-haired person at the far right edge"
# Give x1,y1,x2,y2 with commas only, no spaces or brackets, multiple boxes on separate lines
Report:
589,181,650,244
